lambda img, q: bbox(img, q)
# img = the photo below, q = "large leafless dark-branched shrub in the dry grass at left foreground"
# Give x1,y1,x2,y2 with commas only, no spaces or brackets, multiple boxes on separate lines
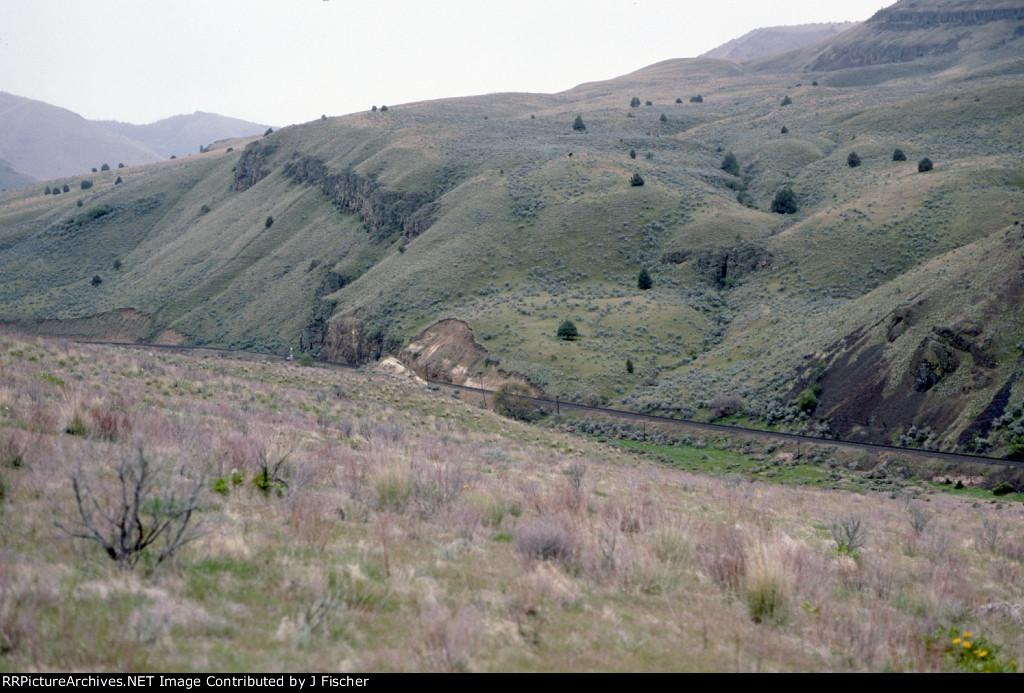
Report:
56,445,205,568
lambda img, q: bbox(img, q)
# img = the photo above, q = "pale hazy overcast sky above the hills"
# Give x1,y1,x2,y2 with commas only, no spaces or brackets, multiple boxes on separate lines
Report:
0,0,893,126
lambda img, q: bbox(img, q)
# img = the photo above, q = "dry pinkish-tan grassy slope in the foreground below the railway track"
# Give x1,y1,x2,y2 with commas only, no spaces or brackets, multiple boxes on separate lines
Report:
0,336,1024,672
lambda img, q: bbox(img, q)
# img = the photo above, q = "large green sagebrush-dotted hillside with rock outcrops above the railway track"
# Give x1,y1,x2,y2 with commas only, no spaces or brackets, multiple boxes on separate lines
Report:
0,0,1024,454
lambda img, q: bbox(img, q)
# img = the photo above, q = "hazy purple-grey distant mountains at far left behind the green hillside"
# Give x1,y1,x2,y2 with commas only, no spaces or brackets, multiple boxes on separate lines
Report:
0,92,266,188
